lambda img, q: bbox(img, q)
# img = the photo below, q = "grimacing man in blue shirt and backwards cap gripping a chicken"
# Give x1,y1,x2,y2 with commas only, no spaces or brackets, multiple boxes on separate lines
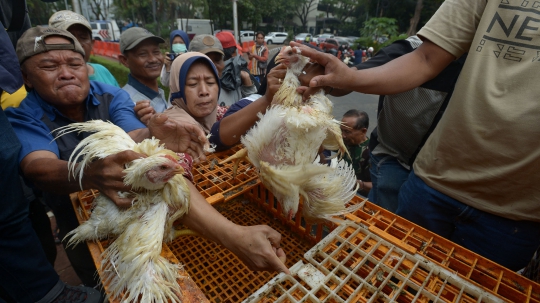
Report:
6,27,208,286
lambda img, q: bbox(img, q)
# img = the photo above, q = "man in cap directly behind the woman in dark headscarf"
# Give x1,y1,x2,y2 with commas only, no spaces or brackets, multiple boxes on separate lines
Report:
189,35,257,107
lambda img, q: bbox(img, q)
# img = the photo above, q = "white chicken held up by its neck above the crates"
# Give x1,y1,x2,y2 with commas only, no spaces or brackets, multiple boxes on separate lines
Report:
222,46,357,221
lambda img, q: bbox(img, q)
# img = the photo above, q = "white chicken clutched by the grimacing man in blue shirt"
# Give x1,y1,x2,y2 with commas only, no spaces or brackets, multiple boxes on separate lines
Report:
58,120,190,303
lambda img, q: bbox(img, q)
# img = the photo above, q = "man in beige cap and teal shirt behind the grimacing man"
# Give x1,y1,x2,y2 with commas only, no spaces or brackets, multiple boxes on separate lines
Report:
49,10,119,87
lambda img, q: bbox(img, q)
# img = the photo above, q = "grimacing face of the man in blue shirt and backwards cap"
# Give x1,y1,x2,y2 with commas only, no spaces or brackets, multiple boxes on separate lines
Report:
23,36,90,108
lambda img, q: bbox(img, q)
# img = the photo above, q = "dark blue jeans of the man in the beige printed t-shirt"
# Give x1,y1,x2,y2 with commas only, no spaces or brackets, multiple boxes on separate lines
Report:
397,171,540,271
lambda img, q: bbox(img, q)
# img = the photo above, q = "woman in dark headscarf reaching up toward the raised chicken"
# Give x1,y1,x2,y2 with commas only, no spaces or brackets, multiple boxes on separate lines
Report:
164,52,286,150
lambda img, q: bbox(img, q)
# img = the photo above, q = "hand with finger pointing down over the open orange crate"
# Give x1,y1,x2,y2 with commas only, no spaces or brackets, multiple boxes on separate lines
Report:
222,225,290,274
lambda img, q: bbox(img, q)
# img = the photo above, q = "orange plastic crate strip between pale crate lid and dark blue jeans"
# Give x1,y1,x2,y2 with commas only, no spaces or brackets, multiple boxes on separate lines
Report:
345,203,540,302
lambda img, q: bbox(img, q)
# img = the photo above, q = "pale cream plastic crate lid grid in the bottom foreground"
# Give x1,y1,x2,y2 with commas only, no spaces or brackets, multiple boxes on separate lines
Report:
244,222,505,303
